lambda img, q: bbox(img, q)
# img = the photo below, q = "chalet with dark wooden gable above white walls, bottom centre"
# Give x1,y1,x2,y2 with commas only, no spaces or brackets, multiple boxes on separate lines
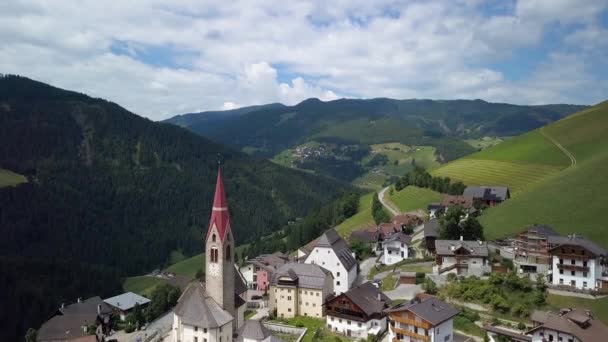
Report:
326,282,391,339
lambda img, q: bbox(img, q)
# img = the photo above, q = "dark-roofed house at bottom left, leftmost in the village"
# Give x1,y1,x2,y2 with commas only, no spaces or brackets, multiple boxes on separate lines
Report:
36,296,112,342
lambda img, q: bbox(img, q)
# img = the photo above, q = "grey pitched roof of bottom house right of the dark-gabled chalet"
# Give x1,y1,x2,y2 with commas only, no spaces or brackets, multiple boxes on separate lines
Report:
386,297,460,326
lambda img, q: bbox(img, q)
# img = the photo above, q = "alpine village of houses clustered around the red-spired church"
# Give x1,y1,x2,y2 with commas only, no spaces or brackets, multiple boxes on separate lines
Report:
37,174,608,342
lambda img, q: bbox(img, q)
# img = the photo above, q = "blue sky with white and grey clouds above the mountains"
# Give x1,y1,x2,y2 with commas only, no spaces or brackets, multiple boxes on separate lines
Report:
0,0,608,120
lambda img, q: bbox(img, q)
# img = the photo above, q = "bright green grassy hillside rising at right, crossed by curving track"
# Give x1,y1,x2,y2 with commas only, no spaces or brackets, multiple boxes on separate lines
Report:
435,102,608,247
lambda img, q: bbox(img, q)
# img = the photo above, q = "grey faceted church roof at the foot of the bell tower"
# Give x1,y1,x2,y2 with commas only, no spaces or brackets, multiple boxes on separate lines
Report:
173,282,233,328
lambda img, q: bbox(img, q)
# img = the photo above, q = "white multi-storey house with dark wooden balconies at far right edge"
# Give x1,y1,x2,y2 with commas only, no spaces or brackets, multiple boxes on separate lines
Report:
548,234,608,292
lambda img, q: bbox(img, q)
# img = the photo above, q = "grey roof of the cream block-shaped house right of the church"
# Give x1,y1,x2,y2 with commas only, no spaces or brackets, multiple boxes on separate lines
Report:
270,262,333,289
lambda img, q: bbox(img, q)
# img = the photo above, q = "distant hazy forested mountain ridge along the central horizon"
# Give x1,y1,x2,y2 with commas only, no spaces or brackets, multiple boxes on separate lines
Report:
166,98,585,161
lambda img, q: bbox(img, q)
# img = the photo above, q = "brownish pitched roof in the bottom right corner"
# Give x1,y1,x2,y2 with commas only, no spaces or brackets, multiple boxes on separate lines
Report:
528,308,608,342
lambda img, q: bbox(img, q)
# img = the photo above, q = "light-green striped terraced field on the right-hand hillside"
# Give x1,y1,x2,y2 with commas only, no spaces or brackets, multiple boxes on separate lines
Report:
431,158,563,196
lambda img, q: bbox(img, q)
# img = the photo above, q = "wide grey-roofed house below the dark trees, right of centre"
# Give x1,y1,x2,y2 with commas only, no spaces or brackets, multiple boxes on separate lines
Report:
433,238,492,277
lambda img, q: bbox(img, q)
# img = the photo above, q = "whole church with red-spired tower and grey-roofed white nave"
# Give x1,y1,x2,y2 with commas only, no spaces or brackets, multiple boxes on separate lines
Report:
171,168,246,342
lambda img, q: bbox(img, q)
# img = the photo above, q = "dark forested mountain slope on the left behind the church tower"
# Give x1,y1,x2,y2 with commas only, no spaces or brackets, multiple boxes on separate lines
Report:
0,76,348,341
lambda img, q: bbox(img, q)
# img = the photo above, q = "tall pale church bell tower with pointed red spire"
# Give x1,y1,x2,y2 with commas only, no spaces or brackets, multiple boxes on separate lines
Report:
205,167,236,317
